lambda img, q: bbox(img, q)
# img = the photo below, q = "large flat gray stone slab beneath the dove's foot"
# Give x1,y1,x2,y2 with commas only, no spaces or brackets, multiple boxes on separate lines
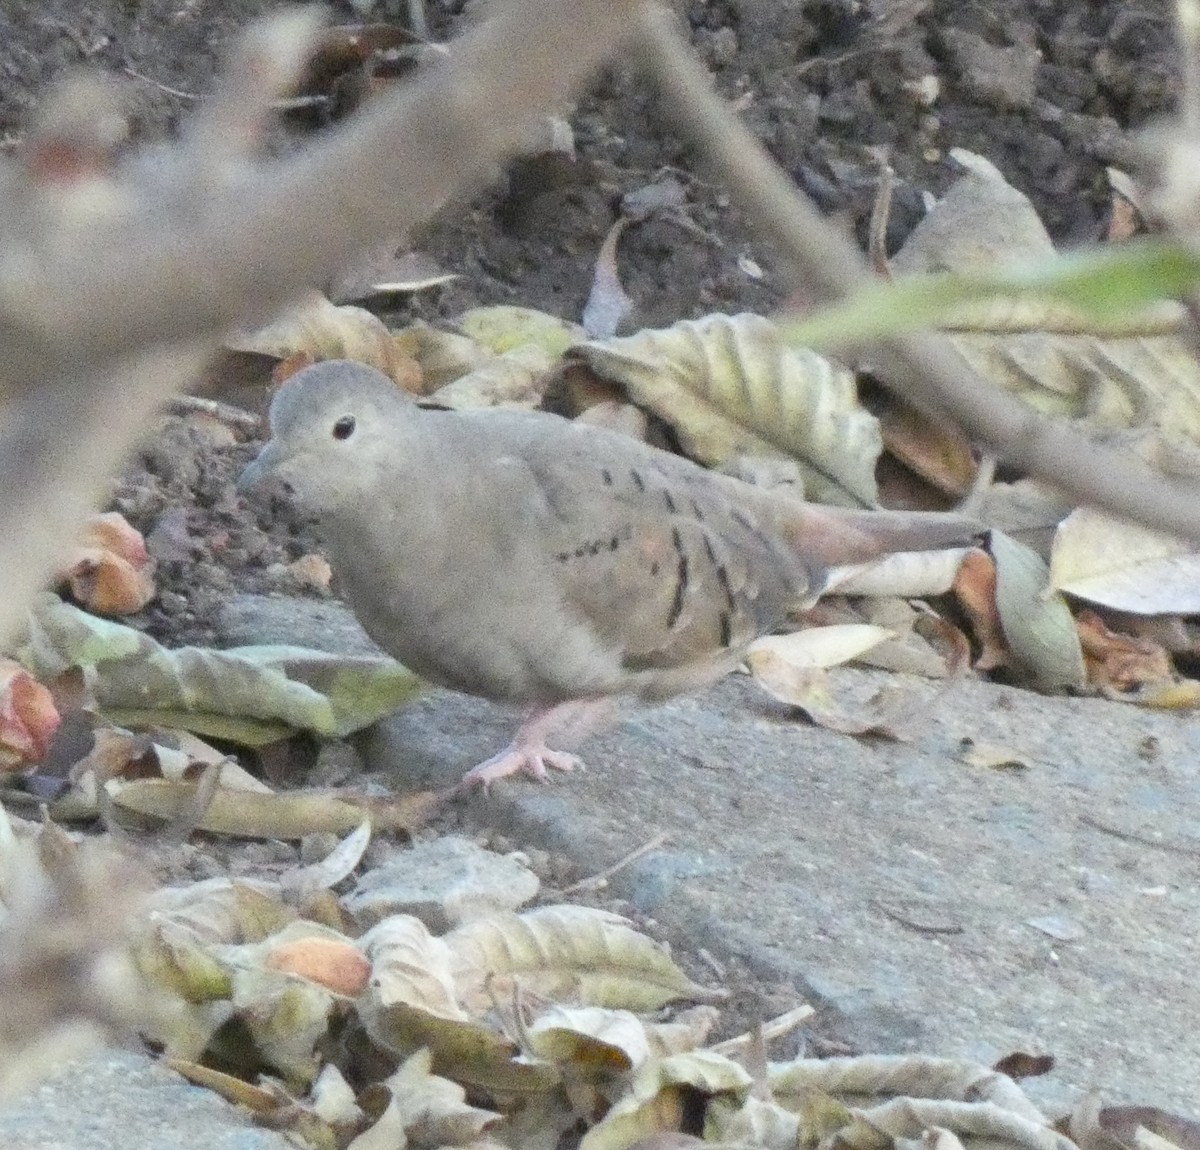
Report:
364,670,1200,1116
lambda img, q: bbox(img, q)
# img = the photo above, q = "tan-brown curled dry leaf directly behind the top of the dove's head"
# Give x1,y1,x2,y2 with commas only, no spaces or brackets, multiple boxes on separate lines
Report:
226,292,421,393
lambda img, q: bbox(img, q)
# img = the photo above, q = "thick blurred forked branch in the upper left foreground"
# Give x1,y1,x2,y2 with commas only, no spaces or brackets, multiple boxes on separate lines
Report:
0,0,636,635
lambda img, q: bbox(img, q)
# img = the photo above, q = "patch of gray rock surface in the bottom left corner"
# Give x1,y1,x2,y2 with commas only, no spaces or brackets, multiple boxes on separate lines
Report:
0,1050,294,1150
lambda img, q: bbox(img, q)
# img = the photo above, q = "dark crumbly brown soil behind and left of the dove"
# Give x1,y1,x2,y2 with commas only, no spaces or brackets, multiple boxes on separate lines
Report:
0,0,1174,1085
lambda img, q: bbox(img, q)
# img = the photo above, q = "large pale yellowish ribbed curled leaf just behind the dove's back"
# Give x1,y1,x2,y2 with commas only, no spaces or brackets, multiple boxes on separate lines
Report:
572,315,883,507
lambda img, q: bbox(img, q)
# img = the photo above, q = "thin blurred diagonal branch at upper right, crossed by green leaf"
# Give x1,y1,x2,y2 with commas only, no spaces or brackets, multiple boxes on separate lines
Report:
640,6,1200,544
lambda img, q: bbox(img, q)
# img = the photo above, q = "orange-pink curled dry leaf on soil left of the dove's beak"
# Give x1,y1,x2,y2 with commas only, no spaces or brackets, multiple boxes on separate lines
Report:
59,511,155,615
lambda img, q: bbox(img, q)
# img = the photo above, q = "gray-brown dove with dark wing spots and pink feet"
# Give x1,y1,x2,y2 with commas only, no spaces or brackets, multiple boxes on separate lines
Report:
238,360,982,789
